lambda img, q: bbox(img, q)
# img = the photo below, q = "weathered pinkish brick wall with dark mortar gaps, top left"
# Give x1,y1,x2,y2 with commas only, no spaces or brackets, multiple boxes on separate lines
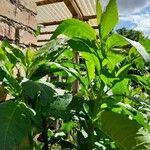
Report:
0,0,37,45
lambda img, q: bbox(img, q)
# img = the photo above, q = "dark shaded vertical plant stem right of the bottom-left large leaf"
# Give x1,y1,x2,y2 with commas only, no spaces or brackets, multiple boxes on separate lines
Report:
42,116,48,150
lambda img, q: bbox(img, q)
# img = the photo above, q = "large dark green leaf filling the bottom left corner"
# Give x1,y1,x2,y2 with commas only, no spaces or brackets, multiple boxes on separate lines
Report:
0,101,34,150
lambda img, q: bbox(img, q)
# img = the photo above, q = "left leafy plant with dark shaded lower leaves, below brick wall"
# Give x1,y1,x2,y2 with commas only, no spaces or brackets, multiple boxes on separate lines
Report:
0,39,75,150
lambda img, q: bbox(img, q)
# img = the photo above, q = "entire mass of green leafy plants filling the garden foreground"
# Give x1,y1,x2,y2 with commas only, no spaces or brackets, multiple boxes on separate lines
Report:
0,0,150,150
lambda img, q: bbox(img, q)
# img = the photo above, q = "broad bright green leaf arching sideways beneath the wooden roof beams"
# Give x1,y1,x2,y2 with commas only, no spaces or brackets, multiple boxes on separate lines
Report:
51,19,96,41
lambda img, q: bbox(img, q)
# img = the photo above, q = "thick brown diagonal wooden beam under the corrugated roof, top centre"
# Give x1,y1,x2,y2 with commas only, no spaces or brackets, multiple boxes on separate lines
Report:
64,0,83,19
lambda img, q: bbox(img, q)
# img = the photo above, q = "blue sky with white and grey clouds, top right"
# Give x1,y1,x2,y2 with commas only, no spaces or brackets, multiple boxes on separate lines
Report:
101,0,150,37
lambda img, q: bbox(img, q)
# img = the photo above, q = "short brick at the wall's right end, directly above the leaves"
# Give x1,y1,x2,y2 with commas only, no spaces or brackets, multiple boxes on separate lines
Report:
19,30,37,45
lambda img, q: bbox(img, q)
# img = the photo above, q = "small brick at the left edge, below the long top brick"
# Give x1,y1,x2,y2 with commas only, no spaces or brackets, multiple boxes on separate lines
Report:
0,22,15,40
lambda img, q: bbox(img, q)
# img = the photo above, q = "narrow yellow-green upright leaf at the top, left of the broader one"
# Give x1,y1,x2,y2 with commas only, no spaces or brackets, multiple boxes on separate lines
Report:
96,0,102,26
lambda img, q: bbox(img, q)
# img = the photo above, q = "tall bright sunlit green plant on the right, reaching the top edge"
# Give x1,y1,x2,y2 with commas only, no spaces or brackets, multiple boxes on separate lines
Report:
48,0,150,150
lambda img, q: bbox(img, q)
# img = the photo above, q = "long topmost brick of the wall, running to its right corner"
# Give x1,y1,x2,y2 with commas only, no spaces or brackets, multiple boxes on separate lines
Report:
0,0,37,29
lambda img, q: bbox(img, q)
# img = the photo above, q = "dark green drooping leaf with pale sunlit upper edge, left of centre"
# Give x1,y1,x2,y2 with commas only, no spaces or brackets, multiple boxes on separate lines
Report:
22,80,56,106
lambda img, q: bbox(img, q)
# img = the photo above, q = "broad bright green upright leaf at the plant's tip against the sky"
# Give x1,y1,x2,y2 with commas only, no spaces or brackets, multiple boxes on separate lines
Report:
101,0,118,38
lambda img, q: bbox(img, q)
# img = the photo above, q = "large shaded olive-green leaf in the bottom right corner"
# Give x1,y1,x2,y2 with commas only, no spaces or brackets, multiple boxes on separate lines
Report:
100,111,150,150
